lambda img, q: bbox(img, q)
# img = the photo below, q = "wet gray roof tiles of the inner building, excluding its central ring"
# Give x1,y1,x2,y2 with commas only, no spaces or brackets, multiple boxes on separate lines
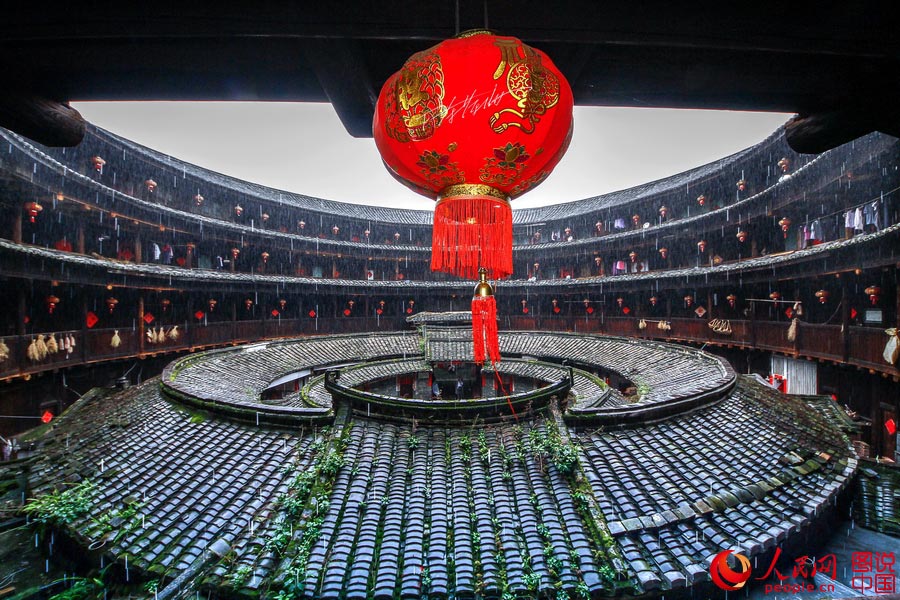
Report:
19,334,856,598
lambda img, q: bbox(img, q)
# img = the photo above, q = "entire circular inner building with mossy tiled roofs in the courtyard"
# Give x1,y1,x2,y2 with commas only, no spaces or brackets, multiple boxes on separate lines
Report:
22,324,857,600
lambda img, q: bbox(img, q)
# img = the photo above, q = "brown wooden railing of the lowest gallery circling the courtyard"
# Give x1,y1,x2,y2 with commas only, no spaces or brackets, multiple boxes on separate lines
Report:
0,314,900,379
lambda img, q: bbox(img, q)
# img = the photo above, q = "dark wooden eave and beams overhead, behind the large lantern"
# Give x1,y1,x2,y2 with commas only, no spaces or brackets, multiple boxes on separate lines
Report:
0,0,900,146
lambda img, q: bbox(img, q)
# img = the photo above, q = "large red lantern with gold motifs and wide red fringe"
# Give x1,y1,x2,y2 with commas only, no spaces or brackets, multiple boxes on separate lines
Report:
373,31,573,279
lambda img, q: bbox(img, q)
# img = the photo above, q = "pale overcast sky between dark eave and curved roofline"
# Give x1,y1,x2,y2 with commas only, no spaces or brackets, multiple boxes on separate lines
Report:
73,102,790,209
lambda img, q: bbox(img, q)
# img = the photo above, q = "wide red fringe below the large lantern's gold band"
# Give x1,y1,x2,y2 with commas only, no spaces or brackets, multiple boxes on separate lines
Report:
431,195,512,279
